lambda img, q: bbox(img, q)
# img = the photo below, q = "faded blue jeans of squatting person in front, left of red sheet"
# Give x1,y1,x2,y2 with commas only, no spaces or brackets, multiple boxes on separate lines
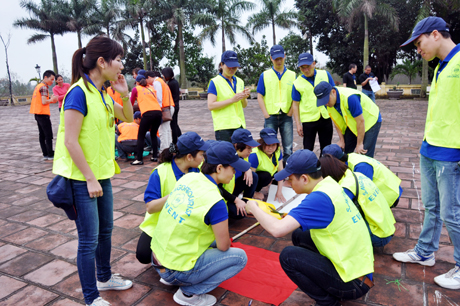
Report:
156,248,248,295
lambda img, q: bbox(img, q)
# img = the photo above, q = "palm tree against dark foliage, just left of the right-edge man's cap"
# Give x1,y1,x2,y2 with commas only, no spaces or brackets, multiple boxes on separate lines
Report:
333,0,399,67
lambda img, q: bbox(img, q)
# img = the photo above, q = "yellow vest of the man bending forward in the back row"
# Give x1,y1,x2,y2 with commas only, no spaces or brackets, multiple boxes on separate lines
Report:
327,87,380,136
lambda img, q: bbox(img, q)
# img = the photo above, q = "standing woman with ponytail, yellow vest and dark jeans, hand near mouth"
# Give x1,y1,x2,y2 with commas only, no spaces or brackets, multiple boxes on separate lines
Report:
53,36,133,306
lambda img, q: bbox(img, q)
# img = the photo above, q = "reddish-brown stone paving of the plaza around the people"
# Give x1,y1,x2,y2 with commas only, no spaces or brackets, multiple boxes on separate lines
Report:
0,100,460,306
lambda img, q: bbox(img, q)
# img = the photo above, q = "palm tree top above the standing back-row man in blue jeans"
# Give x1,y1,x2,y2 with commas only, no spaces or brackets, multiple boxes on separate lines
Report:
247,0,297,45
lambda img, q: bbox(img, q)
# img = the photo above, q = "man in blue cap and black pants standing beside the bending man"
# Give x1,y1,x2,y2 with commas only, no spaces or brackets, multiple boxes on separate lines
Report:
292,53,335,155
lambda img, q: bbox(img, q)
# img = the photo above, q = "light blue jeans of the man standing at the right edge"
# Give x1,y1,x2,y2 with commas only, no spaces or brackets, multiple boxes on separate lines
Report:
415,155,460,265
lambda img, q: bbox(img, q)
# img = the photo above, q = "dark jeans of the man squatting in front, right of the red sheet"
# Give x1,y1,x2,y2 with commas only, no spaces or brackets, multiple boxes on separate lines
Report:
280,229,369,306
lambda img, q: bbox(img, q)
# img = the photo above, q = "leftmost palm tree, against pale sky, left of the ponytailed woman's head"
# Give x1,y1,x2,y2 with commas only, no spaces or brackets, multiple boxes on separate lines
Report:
13,0,69,73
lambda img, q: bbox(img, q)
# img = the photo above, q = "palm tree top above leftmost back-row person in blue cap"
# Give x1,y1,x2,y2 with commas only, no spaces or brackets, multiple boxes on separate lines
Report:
193,0,255,53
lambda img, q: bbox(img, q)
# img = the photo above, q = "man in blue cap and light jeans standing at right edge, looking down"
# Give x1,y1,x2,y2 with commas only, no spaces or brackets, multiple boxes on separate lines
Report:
393,17,460,289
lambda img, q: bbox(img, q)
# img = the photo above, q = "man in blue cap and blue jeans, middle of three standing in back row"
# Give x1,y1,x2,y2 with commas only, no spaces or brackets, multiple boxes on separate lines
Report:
257,45,295,158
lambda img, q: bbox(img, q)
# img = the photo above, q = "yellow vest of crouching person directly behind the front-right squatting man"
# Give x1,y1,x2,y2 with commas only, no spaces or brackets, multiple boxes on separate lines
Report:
339,169,396,238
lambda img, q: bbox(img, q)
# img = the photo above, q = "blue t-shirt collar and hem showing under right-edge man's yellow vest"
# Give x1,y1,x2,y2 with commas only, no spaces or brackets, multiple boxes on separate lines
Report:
420,44,460,162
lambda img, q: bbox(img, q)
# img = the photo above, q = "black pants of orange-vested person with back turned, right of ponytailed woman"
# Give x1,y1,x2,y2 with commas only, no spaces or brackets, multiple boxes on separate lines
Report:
136,111,162,161
